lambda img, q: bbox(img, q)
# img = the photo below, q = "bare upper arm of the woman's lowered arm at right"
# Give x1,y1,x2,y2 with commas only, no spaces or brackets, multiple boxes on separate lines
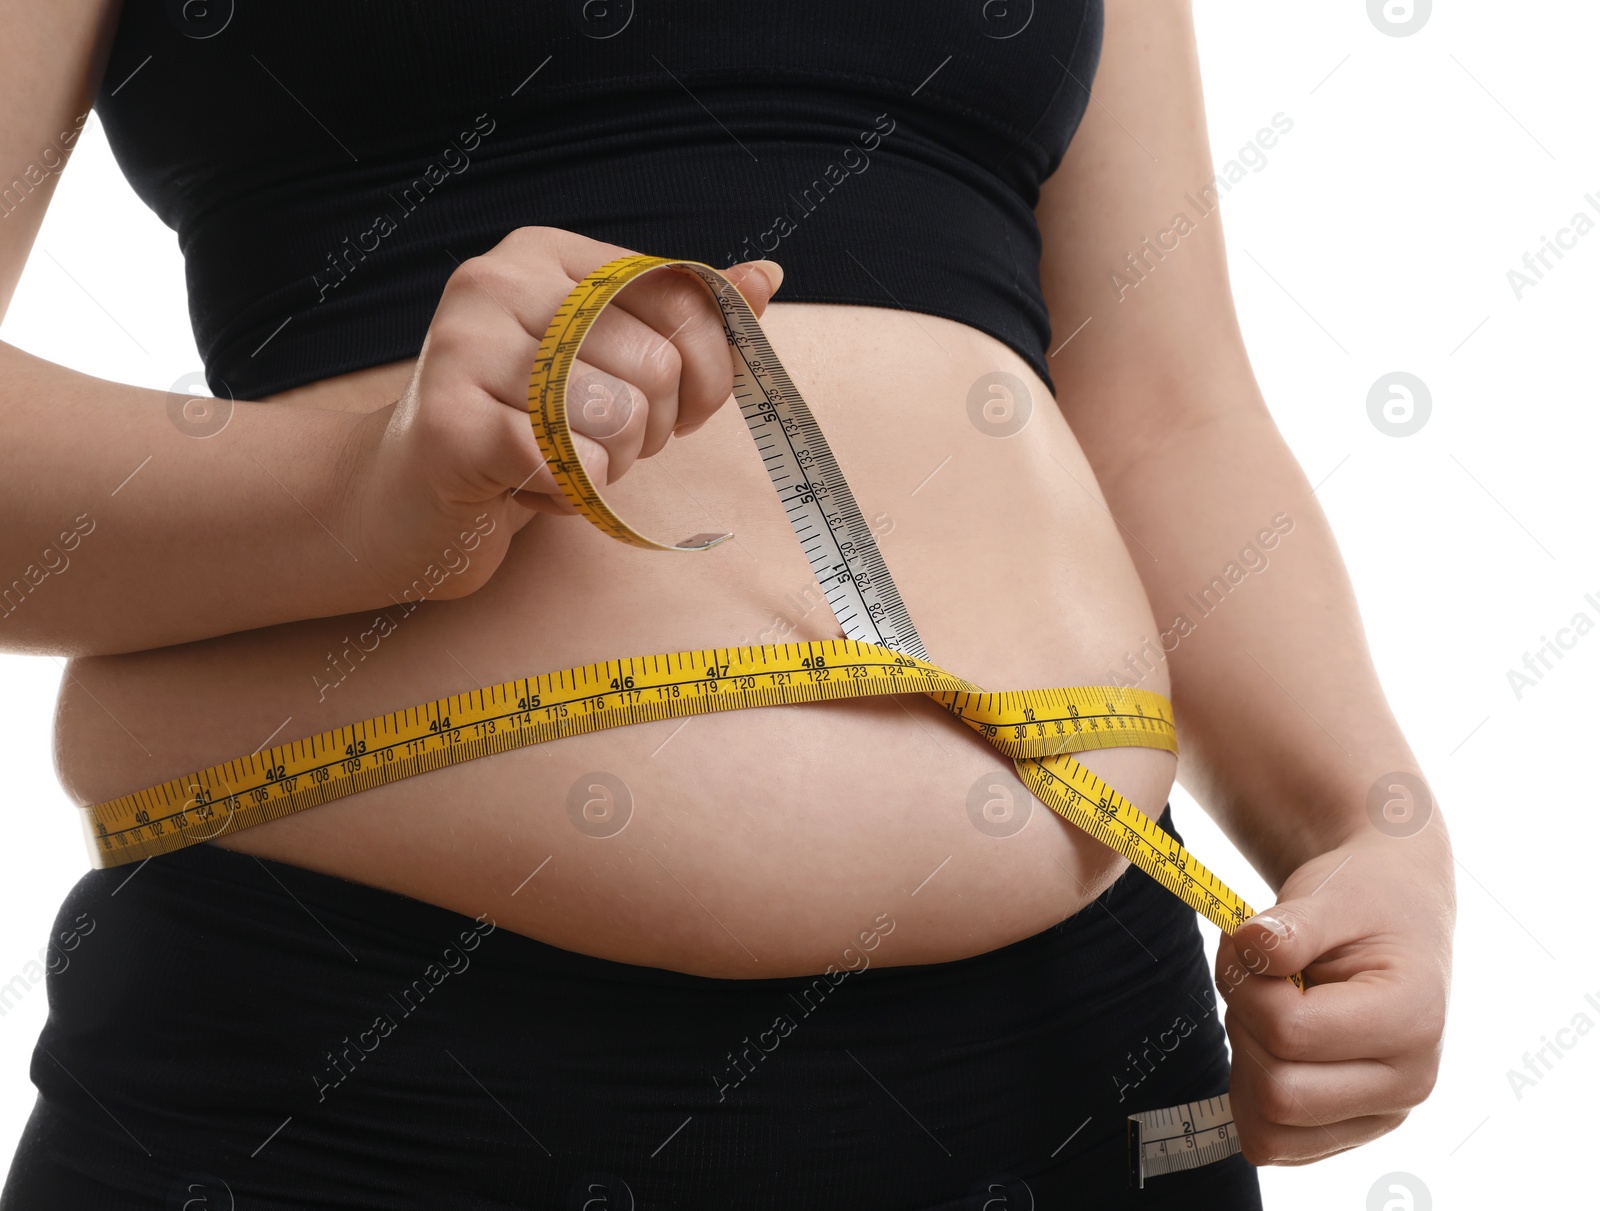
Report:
1037,0,1261,477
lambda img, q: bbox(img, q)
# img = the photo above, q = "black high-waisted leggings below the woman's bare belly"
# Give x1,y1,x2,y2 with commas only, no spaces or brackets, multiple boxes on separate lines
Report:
0,813,1261,1211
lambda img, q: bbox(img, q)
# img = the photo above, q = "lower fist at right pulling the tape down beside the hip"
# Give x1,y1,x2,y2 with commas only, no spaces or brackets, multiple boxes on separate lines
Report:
1216,813,1456,1165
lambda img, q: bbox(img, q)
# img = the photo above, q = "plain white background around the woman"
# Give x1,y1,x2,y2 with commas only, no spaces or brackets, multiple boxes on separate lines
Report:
0,0,1600,1211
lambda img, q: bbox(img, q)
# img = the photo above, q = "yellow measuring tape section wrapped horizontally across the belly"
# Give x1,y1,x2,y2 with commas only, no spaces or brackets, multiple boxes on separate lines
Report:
91,640,1176,865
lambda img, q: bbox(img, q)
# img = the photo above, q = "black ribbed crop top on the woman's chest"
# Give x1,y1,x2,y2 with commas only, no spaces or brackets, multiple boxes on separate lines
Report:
96,0,1102,398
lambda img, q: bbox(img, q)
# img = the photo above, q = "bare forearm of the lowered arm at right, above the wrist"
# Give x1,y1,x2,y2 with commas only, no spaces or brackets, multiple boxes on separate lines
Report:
1101,384,1419,888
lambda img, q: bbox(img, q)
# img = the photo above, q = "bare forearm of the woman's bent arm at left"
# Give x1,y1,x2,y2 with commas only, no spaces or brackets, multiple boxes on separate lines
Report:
0,335,384,656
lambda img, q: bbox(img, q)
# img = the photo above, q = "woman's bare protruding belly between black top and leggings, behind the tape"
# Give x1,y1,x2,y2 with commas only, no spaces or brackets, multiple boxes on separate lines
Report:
56,304,1176,977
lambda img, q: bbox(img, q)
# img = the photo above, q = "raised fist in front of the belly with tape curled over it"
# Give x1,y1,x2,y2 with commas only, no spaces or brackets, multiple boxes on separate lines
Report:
341,227,782,600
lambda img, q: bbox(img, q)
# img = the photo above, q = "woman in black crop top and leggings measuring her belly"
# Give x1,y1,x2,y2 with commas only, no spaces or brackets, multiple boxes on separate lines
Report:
0,0,1453,1208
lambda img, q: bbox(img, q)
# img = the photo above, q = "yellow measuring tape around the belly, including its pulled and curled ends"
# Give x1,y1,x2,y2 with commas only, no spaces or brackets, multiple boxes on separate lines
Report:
83,256,1299,953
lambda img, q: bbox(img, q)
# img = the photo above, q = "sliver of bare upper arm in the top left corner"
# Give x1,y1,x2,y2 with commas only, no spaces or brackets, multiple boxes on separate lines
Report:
0,0,122,317
